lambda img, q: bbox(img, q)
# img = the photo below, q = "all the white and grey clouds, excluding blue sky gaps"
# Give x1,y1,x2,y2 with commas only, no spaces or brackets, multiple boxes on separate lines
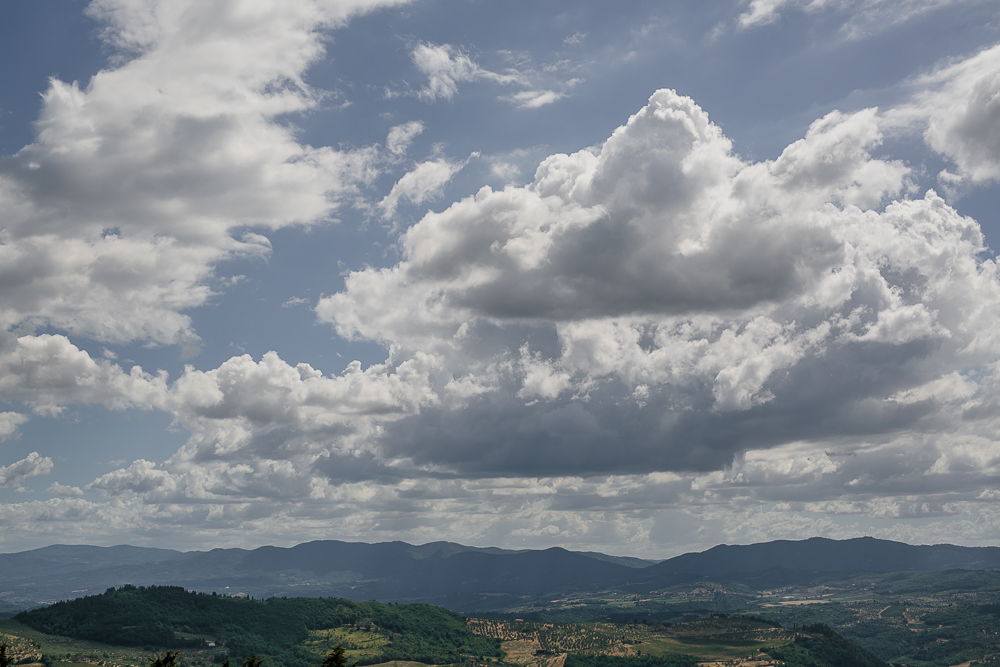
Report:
0,0,1000,555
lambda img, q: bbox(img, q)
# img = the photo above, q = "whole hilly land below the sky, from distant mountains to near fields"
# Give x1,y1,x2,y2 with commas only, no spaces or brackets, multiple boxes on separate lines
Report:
9,538,1000,667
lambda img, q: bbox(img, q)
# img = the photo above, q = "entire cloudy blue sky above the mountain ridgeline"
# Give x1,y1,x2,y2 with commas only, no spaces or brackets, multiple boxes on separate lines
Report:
0,0,1000,558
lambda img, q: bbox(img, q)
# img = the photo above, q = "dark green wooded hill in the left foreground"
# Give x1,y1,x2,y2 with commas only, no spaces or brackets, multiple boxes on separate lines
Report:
16,585,502,667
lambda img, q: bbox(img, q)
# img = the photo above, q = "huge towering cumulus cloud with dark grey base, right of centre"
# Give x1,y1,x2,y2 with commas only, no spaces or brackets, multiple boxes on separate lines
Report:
317,90,1000,475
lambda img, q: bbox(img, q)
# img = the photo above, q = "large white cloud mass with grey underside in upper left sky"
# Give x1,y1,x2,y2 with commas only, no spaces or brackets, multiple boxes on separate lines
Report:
0,0,410,349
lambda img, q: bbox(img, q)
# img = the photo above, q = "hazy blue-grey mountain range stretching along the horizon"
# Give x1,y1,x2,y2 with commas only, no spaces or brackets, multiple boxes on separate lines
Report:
0,537,1000,611
